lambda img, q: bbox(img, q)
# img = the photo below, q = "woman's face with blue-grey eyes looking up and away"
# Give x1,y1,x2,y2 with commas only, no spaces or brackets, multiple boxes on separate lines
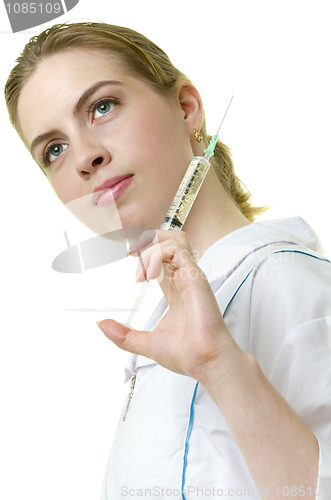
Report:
18,48,199,228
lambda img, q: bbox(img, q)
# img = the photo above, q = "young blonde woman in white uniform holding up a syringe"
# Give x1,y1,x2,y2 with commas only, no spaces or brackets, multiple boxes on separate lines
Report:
5,23,331,500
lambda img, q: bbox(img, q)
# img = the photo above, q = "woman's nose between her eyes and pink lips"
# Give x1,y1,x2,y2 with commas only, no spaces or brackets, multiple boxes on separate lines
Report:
75,137,112,179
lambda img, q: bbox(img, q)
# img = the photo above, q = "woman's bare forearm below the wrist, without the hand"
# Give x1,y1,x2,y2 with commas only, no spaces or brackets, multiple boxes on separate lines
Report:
201,344,319,498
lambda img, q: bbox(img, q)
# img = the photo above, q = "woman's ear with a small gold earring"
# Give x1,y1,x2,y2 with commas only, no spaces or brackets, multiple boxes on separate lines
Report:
178,81,203,137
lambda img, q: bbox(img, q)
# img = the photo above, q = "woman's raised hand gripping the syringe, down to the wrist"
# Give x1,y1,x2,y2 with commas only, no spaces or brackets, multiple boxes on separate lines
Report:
99,230,240,383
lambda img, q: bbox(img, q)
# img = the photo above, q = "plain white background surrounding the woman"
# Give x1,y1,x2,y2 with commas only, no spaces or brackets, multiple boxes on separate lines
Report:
0,0,331,500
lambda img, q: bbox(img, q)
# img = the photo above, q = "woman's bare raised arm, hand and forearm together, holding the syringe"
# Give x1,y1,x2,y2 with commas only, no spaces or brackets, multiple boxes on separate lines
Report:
100,231,326,498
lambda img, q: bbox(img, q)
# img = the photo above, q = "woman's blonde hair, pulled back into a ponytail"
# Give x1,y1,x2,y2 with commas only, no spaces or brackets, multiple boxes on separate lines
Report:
5,22,265,221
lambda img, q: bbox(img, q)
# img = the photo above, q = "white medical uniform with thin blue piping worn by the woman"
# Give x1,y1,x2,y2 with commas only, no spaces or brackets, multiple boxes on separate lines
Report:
102,218,331,500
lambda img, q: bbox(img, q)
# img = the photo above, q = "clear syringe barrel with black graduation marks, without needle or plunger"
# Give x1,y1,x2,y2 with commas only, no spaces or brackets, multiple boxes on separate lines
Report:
161,156,210,231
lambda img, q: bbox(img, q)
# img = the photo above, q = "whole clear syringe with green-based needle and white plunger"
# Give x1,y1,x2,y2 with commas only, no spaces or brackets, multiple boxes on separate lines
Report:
126,96,233,326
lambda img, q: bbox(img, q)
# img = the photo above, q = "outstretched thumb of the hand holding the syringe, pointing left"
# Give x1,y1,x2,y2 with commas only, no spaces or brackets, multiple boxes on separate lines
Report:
97,319,150,356
